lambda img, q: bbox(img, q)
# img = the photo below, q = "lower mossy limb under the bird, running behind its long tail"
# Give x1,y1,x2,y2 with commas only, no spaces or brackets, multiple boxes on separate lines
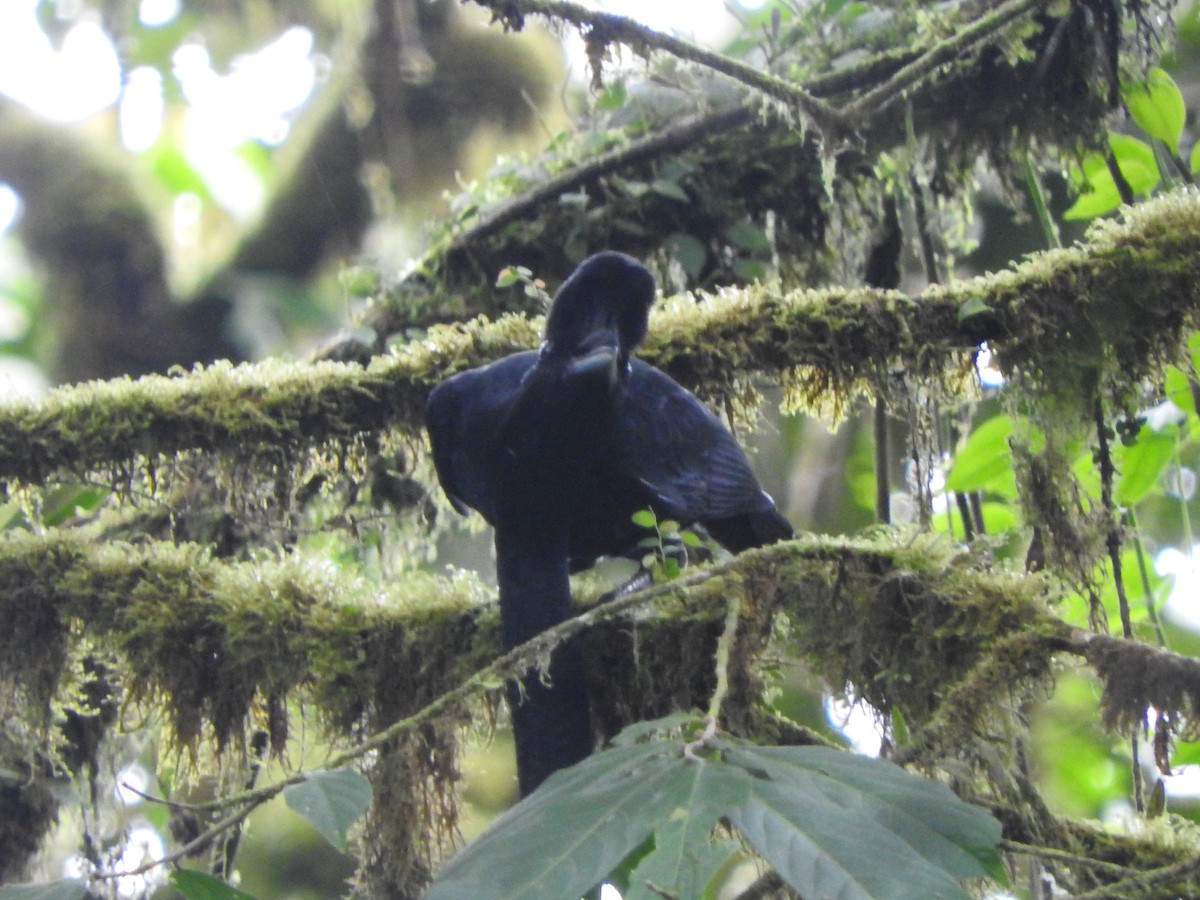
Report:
11,533,1200,897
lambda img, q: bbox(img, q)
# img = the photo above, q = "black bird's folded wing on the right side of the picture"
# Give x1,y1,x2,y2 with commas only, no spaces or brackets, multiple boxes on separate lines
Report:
612,360,770,522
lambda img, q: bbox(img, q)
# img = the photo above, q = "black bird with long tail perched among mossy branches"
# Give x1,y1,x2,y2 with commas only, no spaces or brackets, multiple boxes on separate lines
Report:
426,252,792,794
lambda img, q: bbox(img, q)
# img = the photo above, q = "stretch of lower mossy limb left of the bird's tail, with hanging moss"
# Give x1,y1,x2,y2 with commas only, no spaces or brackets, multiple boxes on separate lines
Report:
0,532,492,746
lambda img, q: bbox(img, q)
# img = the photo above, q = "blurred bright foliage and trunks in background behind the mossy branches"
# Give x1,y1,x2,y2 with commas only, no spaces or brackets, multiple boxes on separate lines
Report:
7,0,1200,899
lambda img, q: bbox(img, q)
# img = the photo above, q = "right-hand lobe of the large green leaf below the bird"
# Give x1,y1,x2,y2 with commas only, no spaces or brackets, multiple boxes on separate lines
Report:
716,740,1006,900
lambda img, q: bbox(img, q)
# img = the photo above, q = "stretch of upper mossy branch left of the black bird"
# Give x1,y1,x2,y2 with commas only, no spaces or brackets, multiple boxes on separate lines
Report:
0,319,536,482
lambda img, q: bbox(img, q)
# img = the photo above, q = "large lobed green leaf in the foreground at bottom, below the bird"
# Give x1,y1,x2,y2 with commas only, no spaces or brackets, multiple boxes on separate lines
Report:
426,728,1004,900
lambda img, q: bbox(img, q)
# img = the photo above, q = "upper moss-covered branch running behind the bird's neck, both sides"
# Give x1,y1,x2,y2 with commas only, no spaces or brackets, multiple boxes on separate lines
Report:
0,191,1200,484
